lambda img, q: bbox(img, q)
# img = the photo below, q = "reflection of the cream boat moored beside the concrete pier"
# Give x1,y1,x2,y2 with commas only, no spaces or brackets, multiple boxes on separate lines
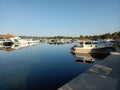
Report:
71,52,109,64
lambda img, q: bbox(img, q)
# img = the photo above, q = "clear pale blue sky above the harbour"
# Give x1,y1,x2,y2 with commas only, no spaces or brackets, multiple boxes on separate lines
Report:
0,0,120,36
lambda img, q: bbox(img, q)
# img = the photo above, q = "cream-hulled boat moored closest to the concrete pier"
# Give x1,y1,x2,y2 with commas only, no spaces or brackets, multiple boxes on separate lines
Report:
72,41,109,53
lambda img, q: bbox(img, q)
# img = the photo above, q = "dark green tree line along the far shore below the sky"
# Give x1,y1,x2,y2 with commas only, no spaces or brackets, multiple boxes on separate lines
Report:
20,31,120,40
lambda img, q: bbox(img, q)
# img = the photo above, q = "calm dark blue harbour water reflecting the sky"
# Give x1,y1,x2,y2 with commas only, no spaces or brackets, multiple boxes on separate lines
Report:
0,44,109,90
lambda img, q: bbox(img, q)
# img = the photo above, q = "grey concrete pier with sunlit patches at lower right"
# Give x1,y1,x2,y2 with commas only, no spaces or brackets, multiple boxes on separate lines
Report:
58,49,120,90
